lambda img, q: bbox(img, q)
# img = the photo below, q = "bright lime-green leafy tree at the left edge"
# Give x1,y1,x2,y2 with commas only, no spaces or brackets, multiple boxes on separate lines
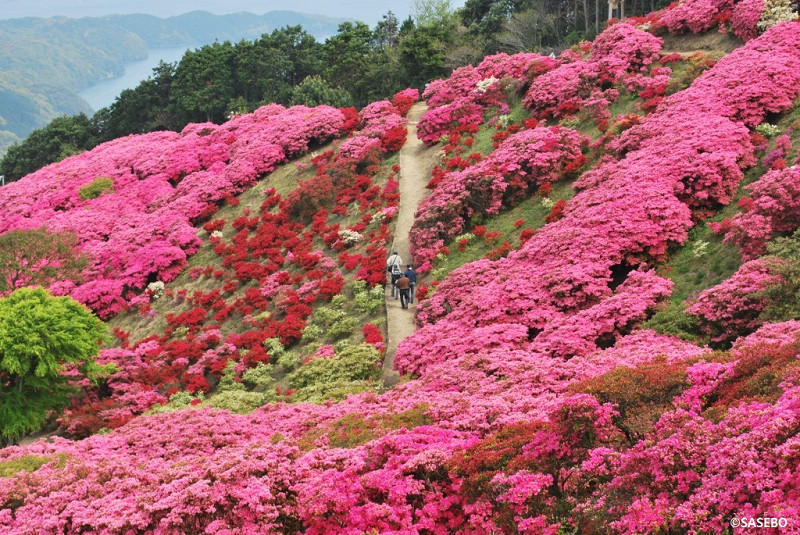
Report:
0,288,113,445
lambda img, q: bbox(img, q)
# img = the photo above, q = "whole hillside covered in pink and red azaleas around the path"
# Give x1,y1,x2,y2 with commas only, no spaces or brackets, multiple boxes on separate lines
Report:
0,0,800,535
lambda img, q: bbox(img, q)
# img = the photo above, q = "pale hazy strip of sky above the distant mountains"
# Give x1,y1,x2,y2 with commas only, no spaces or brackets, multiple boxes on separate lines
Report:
0,0,464,25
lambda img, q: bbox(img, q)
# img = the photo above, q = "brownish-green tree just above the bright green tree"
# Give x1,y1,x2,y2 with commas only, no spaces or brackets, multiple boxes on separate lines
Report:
0,228,86,295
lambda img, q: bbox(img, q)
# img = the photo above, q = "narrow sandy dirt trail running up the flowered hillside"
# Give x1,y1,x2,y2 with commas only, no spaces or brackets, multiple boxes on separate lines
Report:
383,102,437,387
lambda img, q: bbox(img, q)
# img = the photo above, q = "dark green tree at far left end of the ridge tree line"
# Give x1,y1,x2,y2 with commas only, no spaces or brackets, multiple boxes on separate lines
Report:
0,113,98,182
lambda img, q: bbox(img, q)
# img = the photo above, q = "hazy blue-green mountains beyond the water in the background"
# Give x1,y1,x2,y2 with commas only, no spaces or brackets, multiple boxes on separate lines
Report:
0,11,344,156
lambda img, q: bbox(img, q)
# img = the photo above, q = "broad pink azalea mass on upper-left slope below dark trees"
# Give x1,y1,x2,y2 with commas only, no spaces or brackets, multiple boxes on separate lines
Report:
0,105,343,318
